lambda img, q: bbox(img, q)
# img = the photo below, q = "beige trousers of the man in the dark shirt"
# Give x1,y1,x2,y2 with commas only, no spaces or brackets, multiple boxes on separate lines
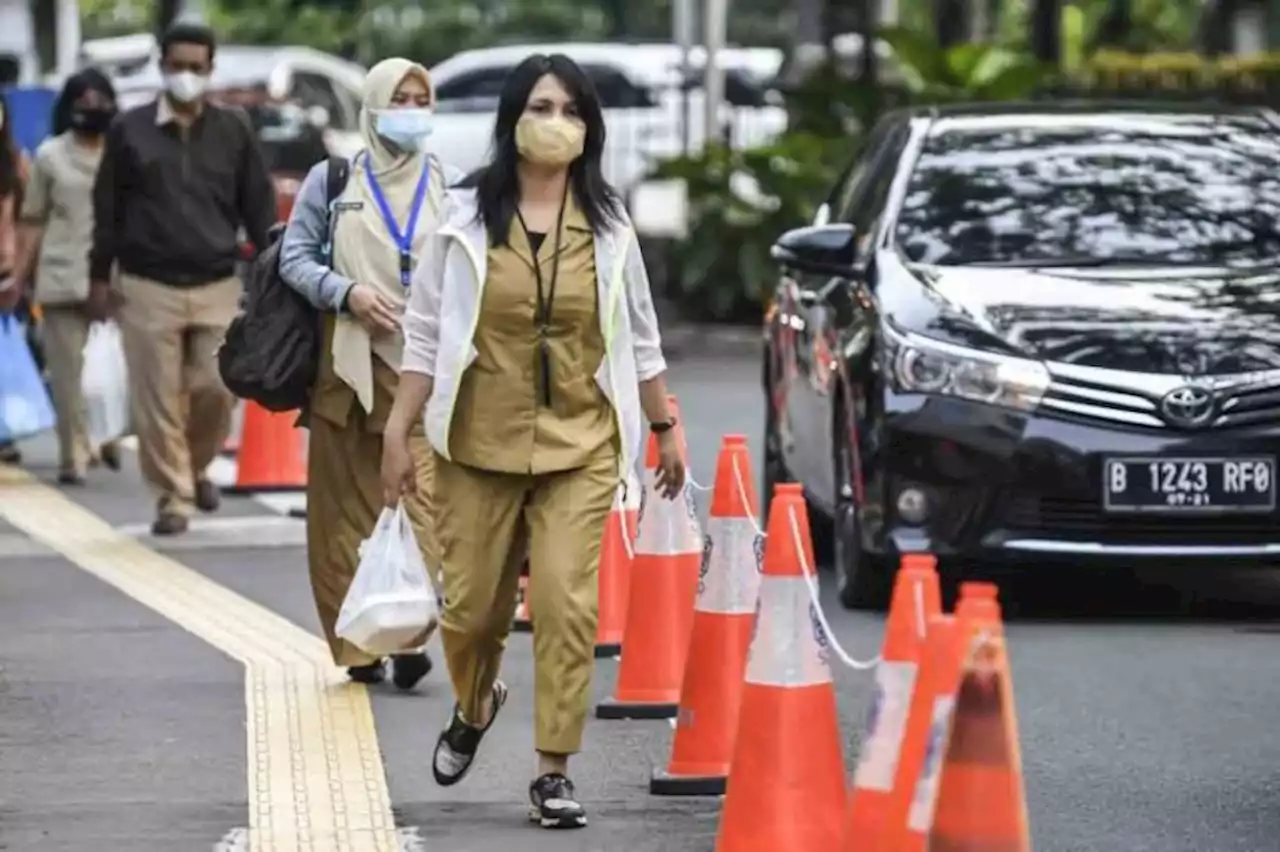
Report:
119,274,241,516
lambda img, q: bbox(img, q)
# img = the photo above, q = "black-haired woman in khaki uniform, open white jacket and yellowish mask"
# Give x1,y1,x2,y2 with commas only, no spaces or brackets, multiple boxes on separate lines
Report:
383,55,685,828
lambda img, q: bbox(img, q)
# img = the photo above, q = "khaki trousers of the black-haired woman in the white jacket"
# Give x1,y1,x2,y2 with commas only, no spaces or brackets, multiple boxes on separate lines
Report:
435,446,618,755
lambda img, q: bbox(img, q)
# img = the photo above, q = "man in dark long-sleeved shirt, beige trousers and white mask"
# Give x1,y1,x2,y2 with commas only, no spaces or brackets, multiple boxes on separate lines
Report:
90,24,275,535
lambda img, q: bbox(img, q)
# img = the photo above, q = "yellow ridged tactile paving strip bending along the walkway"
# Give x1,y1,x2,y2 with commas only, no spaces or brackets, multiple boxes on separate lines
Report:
0,464,399,852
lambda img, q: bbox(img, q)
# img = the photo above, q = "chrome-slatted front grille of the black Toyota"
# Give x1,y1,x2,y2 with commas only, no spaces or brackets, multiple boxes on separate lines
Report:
1041,368,1280,430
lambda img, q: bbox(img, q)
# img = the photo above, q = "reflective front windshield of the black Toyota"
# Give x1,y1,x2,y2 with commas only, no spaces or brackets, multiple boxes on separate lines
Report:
896,114,1280,266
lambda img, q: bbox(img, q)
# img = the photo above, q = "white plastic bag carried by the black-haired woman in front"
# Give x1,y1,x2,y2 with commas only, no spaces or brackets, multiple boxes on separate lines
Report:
334,504,439,656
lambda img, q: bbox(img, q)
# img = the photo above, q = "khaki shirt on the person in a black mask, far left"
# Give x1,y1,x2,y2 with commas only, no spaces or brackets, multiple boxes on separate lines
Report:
20,133,102,306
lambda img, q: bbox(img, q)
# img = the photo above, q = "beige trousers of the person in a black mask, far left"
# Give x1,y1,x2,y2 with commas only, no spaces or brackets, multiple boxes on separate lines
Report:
41,304,97,475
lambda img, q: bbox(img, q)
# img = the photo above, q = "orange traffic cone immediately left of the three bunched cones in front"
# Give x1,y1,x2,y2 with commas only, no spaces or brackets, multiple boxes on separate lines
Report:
716,484,845,852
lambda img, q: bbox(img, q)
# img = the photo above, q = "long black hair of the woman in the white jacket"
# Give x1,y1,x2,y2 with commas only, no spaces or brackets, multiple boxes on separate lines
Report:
476,54,622,246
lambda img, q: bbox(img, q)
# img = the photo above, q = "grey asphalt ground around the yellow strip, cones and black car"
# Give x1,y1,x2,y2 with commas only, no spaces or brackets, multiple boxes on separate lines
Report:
0,347,1280,852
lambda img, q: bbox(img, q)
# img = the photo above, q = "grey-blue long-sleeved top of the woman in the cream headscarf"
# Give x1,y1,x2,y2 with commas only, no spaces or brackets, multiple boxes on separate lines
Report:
280,153,465,313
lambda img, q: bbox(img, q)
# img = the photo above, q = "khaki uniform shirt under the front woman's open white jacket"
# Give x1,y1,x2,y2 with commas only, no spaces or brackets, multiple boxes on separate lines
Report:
449,196,617,475
